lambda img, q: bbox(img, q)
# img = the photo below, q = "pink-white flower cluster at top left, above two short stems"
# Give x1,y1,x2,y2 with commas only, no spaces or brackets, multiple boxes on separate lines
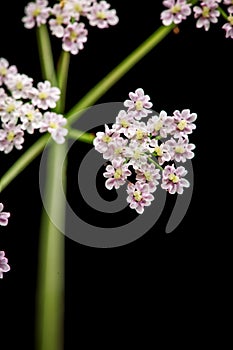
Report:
22,0,119,55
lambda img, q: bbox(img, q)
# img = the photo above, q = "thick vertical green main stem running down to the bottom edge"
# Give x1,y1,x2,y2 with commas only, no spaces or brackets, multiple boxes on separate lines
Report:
36,143,66,350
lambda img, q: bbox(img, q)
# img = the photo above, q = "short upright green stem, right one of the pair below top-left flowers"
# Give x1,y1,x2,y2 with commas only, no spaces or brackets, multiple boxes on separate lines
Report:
56,51,70,113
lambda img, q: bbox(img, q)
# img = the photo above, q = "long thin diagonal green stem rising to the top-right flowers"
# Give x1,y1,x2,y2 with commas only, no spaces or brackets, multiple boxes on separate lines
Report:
67,24,175,123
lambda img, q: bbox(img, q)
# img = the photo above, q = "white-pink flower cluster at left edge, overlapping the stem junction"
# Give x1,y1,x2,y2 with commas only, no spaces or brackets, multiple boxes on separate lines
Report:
0,58,68,153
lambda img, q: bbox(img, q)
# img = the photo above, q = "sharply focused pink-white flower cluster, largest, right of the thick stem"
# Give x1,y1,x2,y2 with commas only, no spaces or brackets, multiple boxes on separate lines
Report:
94,89,197,214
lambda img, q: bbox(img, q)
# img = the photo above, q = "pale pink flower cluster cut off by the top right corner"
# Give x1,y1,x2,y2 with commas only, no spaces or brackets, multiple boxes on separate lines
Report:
161,0,233,38
